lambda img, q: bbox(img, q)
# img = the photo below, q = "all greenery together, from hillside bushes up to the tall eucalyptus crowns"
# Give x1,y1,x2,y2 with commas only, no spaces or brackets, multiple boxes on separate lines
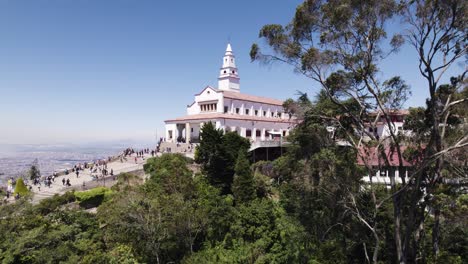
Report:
0,0,468,263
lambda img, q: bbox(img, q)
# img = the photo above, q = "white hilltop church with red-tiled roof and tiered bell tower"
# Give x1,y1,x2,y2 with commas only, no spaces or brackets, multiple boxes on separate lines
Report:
165,44,296,147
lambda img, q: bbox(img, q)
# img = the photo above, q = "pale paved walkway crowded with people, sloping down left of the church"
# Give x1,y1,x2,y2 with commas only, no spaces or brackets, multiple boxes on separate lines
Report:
28,154,151,203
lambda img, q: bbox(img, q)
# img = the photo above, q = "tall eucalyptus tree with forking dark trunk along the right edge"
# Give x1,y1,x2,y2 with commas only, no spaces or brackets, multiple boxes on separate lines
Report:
402,0,468,257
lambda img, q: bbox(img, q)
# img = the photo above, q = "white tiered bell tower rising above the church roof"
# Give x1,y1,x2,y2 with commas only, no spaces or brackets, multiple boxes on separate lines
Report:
218,43,240,92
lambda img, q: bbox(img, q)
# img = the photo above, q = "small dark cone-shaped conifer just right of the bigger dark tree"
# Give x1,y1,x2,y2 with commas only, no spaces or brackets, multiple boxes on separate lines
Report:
232,150,255,203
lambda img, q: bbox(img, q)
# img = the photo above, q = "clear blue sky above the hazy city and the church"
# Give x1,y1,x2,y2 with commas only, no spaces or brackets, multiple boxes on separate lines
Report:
0,0,460,143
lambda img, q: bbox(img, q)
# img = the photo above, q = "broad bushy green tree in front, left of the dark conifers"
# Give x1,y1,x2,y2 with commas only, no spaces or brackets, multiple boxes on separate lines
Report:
98,154,230,263
